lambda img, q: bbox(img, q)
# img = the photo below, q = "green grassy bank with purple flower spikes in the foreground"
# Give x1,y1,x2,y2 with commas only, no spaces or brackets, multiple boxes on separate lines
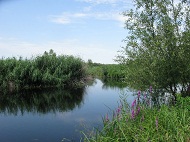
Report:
84,93,190,142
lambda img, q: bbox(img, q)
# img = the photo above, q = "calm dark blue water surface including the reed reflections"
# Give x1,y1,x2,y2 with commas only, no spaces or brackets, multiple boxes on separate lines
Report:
0,80,133,142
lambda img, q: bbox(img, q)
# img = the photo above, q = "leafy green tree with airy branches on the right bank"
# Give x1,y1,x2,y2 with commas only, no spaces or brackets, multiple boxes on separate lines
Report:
116,0,190,96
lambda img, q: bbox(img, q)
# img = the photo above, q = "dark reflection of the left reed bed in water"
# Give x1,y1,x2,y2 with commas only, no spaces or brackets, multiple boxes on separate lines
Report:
0,88,85,115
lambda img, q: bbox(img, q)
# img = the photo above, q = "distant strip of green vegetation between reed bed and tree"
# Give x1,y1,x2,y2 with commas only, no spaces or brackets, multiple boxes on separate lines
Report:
88,61,125,80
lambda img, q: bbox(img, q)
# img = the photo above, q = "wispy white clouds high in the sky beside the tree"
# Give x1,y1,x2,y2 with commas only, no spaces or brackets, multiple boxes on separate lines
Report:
49,0,132,26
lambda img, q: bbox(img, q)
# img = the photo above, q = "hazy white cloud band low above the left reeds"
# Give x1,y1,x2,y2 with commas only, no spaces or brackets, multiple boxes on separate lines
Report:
0,39,118,63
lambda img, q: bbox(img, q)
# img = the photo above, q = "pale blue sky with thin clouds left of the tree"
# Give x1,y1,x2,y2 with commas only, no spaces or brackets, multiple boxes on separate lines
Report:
0,0,132,63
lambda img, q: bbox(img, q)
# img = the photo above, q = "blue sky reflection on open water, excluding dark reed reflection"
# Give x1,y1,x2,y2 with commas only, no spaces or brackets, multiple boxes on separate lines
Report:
0,80,133,142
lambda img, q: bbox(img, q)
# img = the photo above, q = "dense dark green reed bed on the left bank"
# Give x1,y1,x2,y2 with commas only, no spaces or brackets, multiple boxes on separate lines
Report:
0,50,86,90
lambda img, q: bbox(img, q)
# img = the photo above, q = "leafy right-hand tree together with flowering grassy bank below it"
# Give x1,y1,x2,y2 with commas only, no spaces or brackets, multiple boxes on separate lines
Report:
84,0,190,142
